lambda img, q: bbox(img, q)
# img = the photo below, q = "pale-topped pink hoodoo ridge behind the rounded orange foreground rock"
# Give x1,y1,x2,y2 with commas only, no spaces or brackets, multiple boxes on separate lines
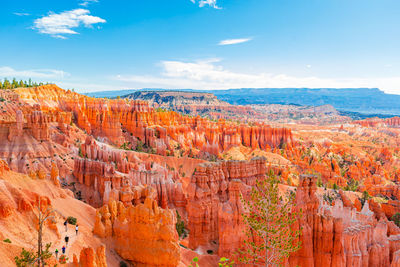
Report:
74,138,186,208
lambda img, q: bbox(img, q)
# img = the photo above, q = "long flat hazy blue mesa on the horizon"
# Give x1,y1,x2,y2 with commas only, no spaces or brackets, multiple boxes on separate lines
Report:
83,88,400,119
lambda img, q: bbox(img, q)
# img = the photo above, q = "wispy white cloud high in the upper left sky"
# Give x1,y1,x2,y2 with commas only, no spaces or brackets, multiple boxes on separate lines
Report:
33,8,106,39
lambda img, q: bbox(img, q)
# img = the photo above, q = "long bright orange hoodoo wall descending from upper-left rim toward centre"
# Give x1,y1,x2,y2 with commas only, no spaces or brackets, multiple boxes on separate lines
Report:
10,85,293,159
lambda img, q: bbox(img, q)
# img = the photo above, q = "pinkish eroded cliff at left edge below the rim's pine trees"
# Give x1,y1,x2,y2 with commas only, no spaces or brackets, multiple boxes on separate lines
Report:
0,90,80,177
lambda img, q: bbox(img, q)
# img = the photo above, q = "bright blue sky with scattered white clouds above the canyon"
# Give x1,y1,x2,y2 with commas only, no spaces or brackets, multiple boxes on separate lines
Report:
0,0,400,94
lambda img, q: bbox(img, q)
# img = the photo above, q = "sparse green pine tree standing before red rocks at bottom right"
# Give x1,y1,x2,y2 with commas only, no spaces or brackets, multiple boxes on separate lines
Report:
239,174,301,266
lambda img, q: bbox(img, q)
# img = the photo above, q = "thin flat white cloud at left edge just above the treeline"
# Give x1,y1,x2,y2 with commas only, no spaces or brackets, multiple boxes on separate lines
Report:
0,67,69,79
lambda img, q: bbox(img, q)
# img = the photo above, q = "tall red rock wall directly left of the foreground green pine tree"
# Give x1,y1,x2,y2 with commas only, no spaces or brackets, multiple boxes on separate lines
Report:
187,158,266,251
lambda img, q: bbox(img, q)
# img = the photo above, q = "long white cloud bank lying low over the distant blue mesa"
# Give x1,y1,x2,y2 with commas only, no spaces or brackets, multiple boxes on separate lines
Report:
114,59,400,94
